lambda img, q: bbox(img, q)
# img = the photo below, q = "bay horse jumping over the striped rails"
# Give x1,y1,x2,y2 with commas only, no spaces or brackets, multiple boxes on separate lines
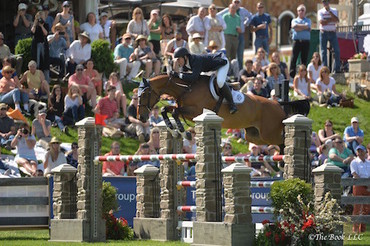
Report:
138,74,309,145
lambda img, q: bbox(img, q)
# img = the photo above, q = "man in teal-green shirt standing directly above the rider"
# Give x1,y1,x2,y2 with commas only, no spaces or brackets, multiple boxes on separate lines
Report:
222,4,242,61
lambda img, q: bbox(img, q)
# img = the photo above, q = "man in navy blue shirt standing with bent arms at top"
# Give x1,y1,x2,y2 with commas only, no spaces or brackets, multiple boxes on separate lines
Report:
250,2,272,56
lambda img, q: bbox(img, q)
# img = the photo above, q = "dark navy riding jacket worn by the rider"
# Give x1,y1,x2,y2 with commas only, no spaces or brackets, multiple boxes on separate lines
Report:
182,53,227,83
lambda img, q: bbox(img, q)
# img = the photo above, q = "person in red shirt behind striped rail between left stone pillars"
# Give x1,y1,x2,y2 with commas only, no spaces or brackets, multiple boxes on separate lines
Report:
103,141,126,177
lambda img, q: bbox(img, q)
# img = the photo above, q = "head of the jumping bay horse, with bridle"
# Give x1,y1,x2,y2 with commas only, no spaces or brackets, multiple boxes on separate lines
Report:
138,79,159,122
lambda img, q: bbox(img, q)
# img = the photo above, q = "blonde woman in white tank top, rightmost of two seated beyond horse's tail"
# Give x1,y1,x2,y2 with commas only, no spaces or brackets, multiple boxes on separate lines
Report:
316,66,342,105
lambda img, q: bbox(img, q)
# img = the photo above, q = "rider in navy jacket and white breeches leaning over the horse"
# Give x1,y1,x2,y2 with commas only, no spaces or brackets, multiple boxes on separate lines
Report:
171,47,238,114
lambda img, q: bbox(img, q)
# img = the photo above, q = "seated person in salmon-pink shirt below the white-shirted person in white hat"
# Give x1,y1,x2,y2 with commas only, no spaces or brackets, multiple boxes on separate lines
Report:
68,64,96,108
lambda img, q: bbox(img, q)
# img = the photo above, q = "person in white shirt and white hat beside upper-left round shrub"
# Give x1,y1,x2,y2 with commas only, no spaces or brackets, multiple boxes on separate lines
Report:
67,32,91,74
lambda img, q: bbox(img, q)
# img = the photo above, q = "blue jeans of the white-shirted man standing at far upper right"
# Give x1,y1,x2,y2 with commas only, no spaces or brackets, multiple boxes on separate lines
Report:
320,32,340,72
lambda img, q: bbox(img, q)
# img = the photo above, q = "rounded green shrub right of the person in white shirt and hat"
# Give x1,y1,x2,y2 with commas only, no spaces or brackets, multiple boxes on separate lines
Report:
91,39,115,78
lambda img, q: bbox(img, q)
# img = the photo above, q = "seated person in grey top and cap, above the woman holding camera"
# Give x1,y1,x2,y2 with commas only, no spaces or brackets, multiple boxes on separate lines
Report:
31,110,51,149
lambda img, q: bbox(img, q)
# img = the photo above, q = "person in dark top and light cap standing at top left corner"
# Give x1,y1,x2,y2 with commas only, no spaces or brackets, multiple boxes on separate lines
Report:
13,3,32,45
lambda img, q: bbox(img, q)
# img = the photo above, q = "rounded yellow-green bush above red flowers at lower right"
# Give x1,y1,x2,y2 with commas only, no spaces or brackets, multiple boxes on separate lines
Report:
270,178,313,214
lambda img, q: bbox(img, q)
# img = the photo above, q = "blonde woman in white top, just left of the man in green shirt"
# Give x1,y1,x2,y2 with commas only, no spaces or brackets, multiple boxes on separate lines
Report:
126,7,150,39
